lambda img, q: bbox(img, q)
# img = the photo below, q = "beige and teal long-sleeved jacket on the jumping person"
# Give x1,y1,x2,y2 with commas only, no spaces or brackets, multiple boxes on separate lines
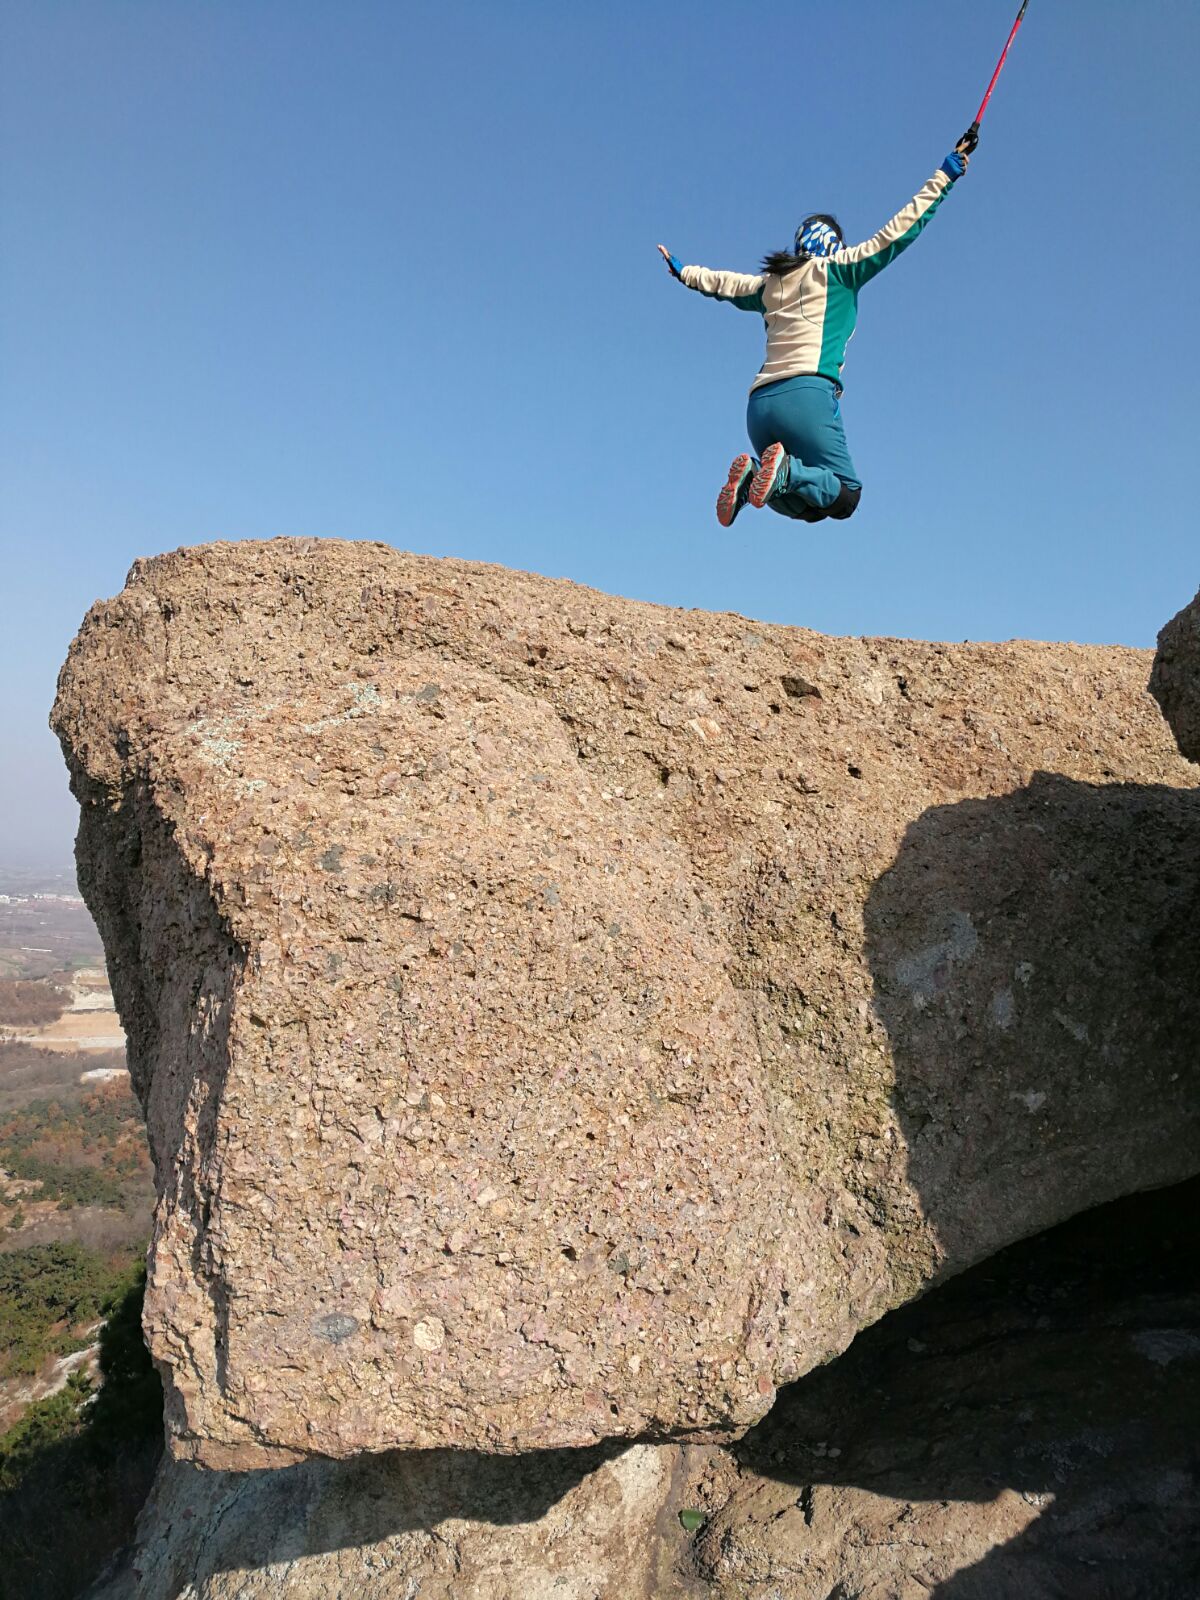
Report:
680,168,952,392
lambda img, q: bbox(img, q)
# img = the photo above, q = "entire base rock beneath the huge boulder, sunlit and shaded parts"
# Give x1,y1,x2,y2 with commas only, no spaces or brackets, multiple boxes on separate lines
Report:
91,1181,1200,1600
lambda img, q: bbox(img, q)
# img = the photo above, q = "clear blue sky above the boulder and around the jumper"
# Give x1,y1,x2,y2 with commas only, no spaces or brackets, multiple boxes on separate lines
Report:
0,0,1200,862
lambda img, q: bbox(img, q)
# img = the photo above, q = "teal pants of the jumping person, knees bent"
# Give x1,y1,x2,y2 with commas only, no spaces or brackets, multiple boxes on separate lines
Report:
746,378,862,522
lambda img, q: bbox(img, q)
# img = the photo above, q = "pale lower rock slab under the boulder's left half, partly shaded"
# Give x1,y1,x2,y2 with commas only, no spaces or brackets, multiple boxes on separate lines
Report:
90,1445,707,1600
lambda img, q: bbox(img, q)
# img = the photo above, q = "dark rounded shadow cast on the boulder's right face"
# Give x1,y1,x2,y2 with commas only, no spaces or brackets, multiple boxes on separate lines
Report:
866,773,1200,1272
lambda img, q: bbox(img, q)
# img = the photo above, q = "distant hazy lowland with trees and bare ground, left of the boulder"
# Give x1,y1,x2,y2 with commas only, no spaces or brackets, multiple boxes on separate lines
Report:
0,874,162,1600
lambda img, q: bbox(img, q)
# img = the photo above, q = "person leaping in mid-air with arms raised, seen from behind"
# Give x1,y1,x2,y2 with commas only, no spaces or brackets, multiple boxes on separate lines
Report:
658,141,970,528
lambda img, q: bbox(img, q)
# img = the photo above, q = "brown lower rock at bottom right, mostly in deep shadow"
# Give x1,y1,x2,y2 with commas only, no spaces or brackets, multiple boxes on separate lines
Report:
698,1181,1200,1600
